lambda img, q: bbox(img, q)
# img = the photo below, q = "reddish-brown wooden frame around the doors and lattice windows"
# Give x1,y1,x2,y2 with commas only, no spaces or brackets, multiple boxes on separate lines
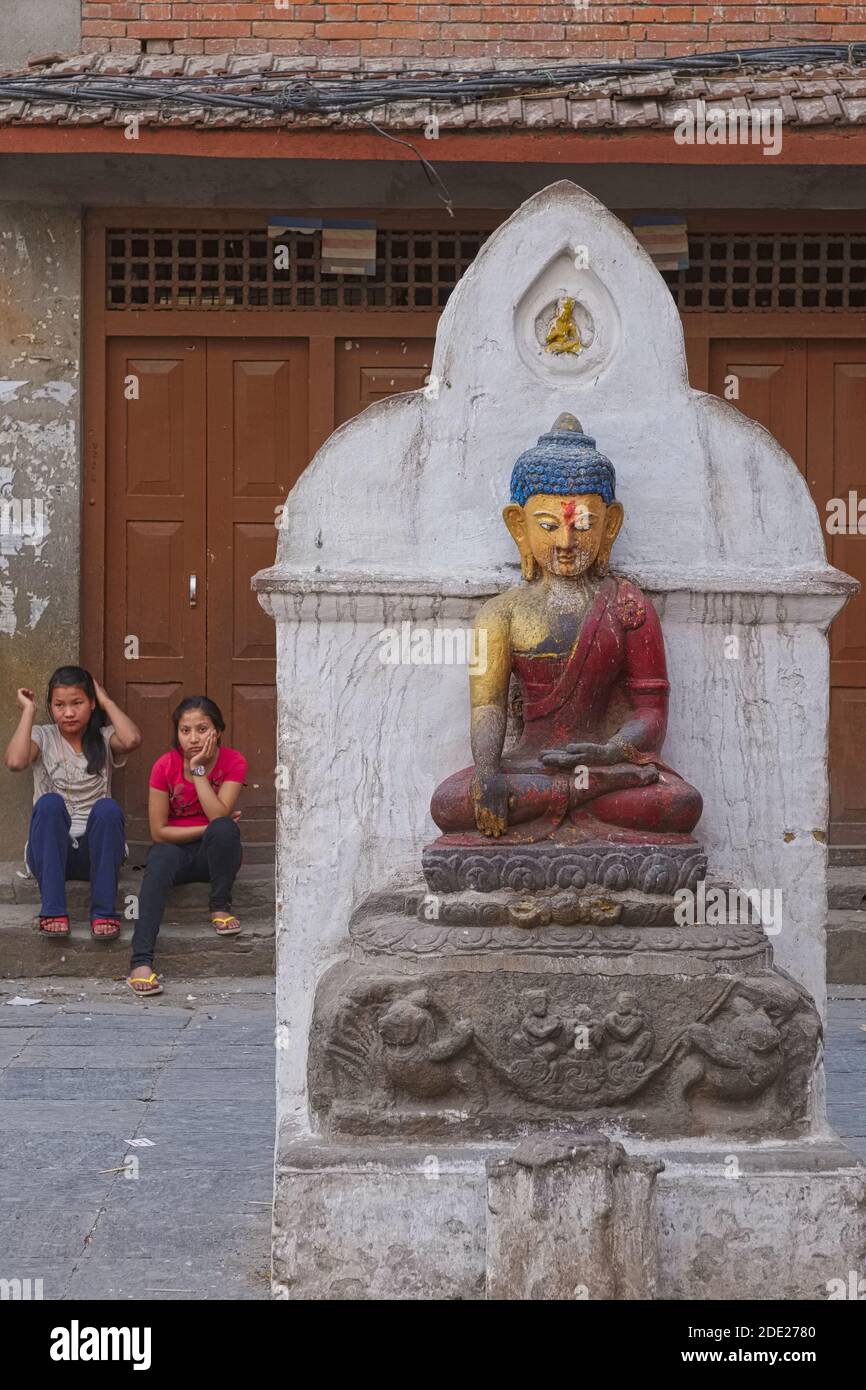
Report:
81,207,866,673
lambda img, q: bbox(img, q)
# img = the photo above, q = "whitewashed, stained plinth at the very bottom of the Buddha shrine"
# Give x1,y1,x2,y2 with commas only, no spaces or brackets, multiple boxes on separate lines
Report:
274,1126,866,1301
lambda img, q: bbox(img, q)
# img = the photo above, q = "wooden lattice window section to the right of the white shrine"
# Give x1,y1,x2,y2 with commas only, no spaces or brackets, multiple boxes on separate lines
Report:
664,232,866,313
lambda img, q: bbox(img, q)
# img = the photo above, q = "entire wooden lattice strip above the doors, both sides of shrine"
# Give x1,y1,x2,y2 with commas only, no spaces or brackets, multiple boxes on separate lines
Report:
106,228,866,313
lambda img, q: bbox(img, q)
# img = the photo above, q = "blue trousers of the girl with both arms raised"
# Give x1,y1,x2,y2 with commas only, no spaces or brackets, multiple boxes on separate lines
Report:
26,791,125,922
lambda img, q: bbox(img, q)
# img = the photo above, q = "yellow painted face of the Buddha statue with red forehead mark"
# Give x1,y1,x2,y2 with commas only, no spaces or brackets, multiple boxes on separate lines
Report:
502,492,623,580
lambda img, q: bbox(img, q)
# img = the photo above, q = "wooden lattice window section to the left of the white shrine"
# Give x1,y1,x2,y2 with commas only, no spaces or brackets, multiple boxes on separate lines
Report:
106,228,489,310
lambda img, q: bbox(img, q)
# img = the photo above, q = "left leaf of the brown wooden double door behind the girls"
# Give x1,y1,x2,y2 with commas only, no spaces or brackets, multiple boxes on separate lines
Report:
104,338,206,841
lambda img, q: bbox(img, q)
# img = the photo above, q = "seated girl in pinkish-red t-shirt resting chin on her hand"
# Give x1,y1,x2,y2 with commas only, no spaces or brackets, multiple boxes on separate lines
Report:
126,695,246,994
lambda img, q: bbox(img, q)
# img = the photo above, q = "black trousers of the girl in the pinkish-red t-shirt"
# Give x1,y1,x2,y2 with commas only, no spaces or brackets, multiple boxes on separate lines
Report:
132,816,242,967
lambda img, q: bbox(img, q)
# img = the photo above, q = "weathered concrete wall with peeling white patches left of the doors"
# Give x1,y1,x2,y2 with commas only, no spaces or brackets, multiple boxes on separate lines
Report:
0,204,81,859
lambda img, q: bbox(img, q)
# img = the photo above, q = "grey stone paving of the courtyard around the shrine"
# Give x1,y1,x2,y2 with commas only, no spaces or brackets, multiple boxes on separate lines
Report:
0,979,866,1300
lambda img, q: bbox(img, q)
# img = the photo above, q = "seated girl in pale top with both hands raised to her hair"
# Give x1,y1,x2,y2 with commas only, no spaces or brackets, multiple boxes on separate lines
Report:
6,666,142,941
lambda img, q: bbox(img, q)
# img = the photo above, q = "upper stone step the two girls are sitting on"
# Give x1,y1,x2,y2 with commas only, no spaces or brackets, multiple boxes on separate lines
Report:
0,859,275,922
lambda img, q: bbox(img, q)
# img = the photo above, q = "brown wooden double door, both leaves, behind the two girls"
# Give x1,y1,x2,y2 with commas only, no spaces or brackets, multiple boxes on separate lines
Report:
104,338,309,844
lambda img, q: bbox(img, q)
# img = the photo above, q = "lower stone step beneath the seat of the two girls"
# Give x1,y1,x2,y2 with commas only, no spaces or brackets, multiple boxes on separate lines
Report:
0,904,274,980
